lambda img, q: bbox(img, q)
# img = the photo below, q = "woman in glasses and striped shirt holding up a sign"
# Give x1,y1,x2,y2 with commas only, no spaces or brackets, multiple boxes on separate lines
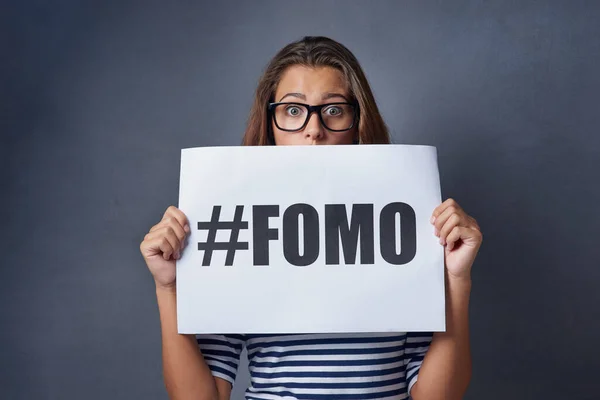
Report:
140,37,482,400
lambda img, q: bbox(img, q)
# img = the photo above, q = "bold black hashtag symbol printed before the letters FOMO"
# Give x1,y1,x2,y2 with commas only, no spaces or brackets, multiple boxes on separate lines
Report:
198,206,248,267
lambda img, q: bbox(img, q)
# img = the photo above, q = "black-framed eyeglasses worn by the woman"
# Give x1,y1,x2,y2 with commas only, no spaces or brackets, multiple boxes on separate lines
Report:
269,103,358,132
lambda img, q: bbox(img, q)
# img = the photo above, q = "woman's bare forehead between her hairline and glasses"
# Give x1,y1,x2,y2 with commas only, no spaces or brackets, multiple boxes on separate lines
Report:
275,65,348,98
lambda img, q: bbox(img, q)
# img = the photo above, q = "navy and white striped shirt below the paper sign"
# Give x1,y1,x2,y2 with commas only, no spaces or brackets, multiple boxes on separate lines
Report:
196,333,432,400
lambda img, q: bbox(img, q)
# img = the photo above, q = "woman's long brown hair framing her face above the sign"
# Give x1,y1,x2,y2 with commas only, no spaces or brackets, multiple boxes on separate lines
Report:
243,36,390,146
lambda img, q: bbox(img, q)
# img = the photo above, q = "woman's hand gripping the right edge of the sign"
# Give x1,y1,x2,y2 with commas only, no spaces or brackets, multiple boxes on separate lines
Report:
431,199,483,280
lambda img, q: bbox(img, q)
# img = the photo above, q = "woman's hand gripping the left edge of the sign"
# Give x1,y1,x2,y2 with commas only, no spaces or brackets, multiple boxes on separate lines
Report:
140,206,190,288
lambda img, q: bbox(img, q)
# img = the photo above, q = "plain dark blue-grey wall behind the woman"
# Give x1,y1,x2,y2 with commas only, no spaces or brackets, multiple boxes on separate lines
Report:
0,1,600,400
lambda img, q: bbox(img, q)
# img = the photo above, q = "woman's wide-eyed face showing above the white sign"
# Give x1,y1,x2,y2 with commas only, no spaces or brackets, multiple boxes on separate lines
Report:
271,65,358,145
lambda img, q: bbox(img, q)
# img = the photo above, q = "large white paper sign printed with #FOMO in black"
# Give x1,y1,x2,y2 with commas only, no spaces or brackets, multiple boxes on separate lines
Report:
177,145,445,333
